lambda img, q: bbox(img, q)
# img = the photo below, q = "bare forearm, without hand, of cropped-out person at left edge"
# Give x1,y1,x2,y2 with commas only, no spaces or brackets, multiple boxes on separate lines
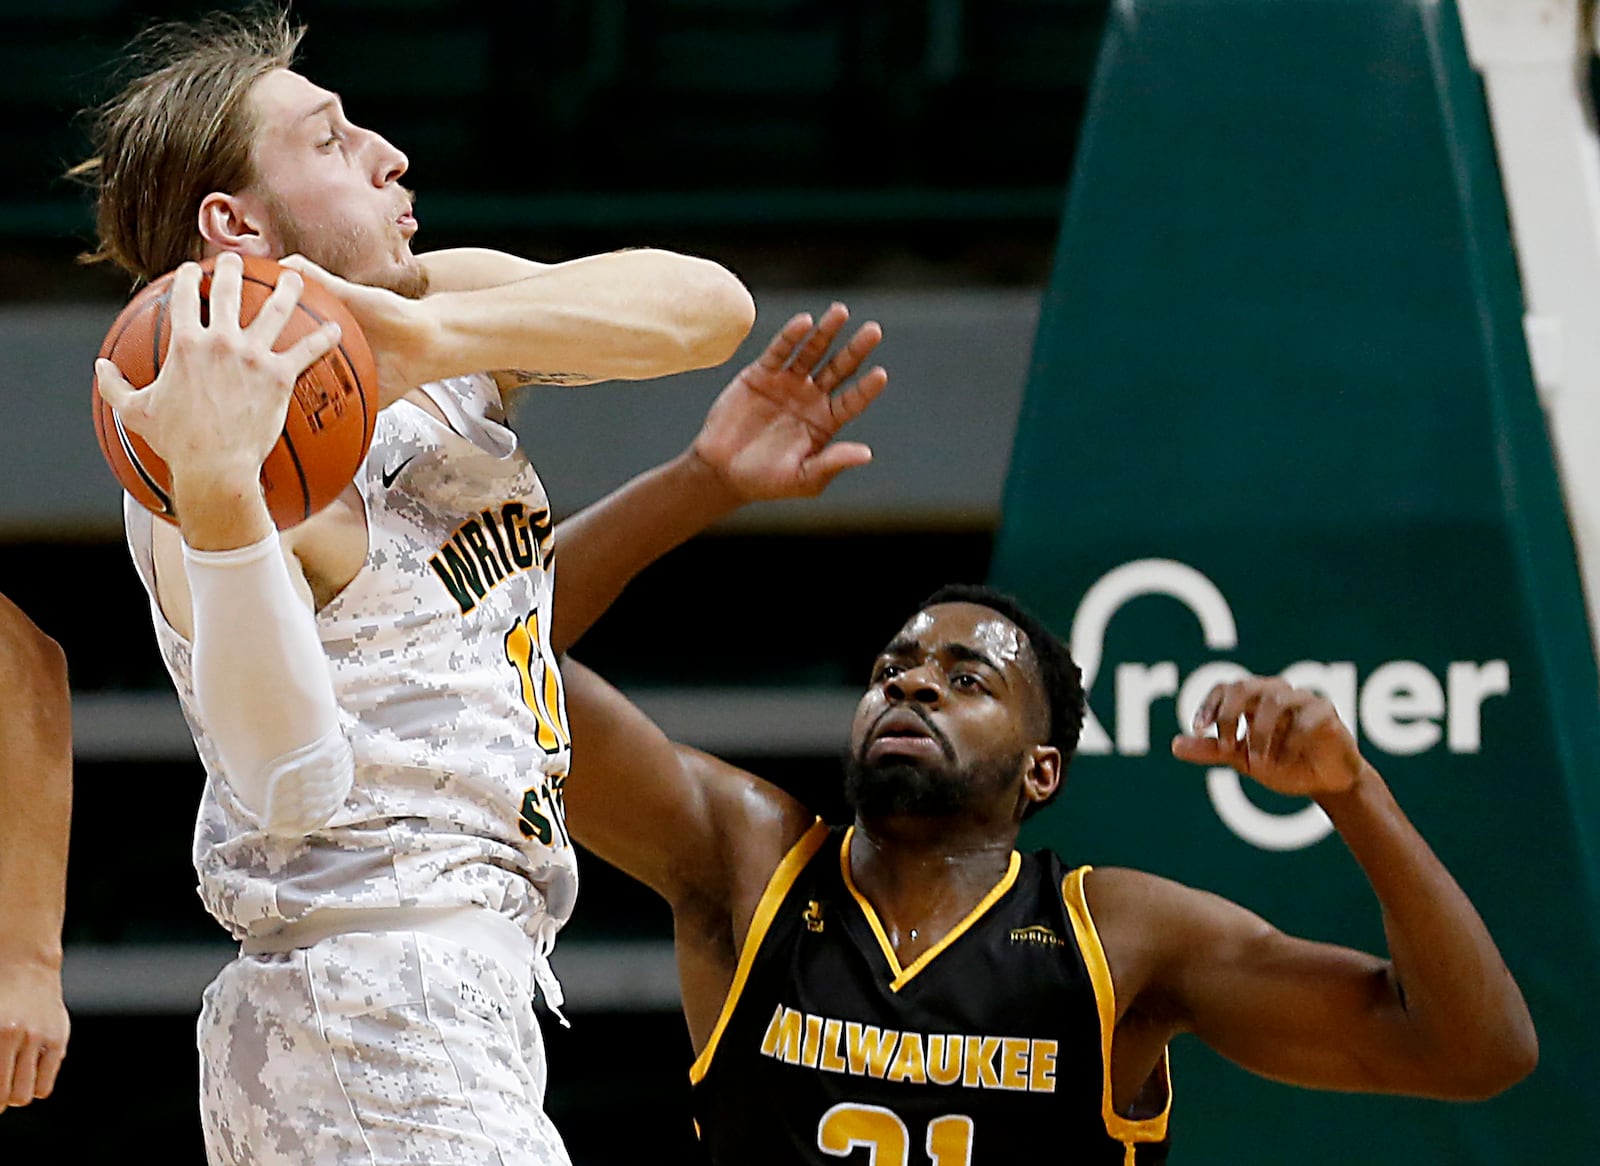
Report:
0,617,72,969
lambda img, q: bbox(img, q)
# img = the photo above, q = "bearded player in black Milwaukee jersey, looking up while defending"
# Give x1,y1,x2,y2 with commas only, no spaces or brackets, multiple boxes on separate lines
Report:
565,587,1538,1166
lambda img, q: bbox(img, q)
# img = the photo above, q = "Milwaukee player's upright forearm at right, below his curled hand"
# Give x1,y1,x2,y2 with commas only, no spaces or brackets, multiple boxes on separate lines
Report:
1318,766,1538,1096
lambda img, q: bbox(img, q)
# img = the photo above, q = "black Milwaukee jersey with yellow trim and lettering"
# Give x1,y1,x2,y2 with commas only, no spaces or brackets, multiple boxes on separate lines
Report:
690,822,1171,1166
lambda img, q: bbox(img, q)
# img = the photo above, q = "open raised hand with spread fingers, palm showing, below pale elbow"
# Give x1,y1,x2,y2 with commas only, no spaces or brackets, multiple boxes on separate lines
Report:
693,304,888,502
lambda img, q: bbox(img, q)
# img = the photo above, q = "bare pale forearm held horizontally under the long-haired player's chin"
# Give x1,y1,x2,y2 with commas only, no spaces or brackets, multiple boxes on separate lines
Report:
403,250,755,384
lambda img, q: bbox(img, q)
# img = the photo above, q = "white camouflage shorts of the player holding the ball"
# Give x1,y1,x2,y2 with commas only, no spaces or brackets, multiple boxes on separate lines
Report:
198,931,570,1166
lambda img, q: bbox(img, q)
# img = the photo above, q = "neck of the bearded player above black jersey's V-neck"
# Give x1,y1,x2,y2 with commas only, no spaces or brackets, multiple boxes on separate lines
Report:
850,821,1016,955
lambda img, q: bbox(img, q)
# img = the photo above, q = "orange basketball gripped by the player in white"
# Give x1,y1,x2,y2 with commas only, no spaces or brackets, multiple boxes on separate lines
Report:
91,256,378,529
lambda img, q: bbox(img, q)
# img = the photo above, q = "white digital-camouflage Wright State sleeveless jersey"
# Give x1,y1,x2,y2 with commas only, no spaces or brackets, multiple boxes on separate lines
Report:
125,374,578,953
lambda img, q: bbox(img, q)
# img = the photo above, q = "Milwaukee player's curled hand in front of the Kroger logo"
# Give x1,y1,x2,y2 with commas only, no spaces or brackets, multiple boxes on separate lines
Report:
1173,677,1366,798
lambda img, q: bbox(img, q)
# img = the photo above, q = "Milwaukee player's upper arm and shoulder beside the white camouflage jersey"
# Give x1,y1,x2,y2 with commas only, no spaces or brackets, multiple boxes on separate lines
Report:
562,657,813,908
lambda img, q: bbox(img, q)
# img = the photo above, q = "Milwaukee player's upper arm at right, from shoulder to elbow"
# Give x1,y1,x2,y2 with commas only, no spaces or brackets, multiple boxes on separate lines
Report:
1085,869,1506,1099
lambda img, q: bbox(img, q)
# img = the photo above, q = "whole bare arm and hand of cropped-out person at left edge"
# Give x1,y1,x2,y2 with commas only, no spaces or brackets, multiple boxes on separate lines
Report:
0,595,72,1112
